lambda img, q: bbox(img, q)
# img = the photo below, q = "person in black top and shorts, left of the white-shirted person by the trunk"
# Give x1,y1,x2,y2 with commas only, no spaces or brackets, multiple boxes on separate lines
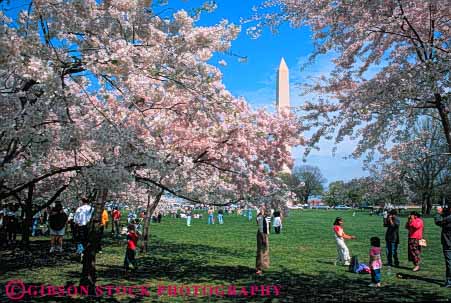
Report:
49,201,67,253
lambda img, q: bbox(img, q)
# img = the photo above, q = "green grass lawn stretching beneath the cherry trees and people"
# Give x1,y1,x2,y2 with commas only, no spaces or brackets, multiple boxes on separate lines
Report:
0,210,451,302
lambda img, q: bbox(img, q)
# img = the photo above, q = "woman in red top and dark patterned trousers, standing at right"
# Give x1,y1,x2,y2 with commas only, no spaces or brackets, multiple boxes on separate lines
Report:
406,211,424,271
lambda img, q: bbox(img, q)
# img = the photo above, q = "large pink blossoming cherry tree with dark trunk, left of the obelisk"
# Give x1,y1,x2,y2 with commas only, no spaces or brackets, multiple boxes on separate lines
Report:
0,0,302,290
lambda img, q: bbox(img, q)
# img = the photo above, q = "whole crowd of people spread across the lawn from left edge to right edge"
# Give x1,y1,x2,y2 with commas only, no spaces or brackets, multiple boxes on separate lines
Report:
0,197,451,287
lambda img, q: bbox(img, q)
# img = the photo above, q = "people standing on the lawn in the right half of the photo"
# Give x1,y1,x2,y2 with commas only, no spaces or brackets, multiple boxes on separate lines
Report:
256,206,451,288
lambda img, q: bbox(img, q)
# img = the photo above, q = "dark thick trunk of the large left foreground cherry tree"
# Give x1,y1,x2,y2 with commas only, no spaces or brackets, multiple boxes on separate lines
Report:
80,189,108,295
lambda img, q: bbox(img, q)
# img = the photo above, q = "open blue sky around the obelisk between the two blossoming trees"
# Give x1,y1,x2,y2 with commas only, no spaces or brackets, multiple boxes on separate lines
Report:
169,0,367,183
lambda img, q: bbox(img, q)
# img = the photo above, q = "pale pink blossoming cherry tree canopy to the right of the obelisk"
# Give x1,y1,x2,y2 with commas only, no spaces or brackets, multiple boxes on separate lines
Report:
248,0,451,156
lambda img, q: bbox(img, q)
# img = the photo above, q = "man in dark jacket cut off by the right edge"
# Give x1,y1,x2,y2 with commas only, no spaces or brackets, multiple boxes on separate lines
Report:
434,205,451,288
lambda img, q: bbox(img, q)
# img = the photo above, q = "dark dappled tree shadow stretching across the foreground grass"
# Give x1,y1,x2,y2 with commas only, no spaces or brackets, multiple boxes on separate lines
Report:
0,239,447,303
